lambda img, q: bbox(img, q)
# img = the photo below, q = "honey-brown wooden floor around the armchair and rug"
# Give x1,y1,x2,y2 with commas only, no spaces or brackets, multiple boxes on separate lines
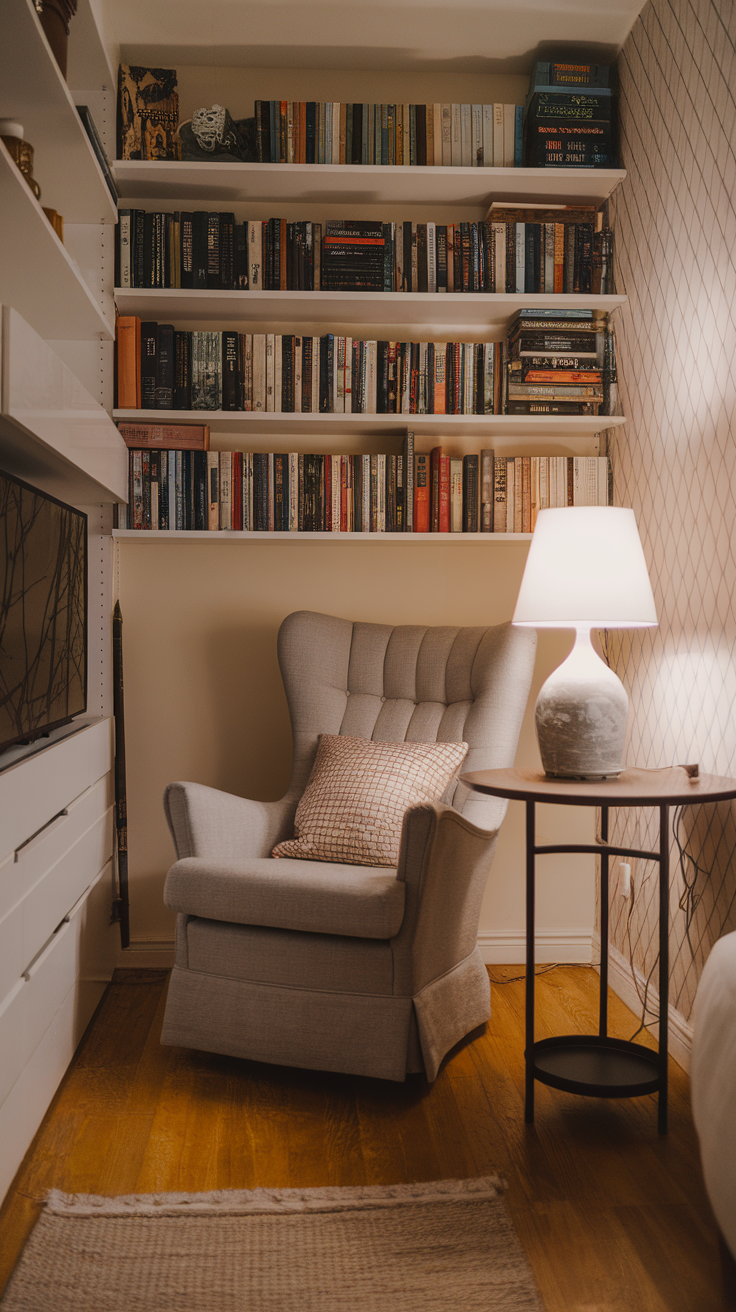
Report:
0,967,723,1312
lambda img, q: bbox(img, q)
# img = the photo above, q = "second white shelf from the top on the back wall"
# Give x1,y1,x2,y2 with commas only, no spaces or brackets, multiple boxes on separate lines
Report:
115,287,626,337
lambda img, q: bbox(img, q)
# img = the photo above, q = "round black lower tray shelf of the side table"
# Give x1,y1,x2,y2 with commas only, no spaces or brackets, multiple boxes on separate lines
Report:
533,1034,660,1098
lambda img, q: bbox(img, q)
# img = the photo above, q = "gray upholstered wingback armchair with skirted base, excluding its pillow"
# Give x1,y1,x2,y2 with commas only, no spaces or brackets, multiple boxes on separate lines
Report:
161,611,537,1080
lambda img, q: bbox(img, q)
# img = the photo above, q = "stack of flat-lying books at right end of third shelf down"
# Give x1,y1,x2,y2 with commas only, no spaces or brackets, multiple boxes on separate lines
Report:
506,310,606,415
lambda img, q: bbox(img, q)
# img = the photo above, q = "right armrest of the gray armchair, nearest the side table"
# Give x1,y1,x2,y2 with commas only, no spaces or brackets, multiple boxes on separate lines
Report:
392,804,499,994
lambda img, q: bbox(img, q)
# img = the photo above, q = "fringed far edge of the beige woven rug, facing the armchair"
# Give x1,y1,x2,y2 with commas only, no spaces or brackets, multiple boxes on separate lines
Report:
45,1176,506,1216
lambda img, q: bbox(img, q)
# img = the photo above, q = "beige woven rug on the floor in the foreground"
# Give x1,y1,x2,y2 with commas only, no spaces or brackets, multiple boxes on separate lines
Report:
0,1176,542,1312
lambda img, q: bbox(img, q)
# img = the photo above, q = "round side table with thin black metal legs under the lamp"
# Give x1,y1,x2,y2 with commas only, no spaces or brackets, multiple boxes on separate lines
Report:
460,766,736,1135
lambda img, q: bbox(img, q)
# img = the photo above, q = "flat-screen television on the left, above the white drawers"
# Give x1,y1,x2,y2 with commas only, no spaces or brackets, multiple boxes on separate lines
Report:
0,471,87,752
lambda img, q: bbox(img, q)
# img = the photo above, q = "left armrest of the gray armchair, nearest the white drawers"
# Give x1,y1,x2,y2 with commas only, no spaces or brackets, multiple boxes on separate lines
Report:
164,783,298,861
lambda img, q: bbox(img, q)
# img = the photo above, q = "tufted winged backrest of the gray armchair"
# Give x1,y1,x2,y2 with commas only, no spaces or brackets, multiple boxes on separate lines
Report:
278,610,537,829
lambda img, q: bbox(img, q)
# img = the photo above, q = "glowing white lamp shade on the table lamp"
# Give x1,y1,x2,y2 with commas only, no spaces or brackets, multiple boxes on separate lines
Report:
513,506,657,628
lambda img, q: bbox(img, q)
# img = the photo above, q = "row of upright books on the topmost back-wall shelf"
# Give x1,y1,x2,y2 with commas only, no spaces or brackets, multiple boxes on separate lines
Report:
255,100,523,168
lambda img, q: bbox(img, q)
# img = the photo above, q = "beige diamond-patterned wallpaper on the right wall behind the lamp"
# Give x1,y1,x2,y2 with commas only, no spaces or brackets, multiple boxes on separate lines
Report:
609,0,736,1019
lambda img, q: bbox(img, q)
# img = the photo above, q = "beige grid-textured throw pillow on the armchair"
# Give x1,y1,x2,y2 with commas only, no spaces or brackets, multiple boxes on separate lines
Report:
272,733,467,866
